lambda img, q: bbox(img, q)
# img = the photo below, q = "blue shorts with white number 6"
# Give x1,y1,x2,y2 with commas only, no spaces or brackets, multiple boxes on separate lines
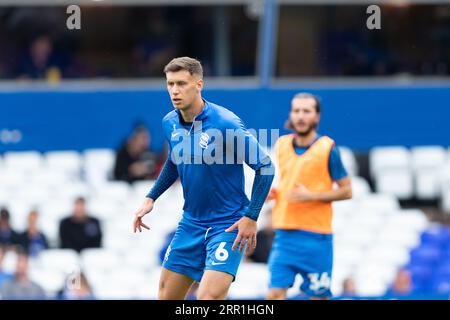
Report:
162,217,244,282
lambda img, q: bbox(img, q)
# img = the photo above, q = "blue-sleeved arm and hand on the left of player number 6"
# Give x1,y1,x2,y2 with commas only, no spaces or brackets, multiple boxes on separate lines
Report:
133,159,178,232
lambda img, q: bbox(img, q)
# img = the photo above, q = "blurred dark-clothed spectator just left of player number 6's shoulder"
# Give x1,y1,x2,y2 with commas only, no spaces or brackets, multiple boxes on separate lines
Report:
114,126,163,183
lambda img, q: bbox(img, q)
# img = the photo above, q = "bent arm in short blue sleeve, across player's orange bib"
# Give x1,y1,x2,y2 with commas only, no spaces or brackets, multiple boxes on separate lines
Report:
286,146,352,202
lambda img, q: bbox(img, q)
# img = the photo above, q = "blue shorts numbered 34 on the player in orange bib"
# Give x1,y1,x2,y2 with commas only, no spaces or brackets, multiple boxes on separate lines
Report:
269,230,333,297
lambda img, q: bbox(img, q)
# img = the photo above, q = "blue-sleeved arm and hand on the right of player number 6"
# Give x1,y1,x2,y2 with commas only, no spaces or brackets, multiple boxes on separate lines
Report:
225,121,275,253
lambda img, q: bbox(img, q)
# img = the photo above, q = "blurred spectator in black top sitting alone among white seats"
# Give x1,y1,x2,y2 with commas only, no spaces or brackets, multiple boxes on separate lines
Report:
59,197,102,252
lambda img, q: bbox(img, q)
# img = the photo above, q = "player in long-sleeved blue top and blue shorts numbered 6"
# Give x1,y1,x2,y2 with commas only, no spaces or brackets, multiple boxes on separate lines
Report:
134,57,274,299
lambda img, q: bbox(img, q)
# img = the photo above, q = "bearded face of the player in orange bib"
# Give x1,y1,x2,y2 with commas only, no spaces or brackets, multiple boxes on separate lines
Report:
289,98,320,135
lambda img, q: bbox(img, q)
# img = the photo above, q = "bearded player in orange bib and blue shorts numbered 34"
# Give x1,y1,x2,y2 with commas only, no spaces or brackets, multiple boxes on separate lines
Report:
268,93,352,299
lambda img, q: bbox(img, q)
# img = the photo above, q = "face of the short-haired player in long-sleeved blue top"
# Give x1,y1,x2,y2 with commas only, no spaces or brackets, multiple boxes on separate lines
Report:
166,70,203,110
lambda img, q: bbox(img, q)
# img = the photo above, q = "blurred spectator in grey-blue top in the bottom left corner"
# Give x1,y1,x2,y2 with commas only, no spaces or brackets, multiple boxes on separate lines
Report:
1,252,45,299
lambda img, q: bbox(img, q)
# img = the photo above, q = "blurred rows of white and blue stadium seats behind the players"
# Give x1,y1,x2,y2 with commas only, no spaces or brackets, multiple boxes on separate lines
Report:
0,147,450,299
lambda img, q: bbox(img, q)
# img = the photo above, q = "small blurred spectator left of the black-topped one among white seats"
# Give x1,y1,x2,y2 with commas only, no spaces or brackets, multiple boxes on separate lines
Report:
20,210,48,257
